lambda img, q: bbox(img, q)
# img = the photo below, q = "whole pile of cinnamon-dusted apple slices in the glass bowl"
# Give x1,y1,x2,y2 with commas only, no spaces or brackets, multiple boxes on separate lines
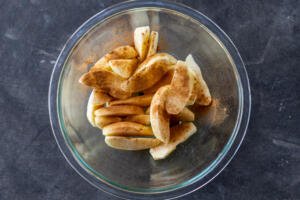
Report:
79,26,211,160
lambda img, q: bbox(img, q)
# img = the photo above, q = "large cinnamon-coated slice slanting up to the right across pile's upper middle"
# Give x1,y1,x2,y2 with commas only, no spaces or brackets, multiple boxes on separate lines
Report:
122,53,177,93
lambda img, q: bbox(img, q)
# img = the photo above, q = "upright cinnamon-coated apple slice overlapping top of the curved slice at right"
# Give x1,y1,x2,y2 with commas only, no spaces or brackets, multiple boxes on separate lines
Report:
166,61,194,115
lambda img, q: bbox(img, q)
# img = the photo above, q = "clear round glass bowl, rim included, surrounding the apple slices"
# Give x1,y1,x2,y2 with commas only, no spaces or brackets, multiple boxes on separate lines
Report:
49,1,250,199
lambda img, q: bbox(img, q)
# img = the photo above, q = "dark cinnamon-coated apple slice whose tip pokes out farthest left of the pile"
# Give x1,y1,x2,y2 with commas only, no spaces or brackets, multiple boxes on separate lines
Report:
79,70,131,99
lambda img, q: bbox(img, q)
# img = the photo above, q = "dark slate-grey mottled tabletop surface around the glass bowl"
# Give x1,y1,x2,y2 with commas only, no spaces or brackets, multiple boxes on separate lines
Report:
0,0,300,200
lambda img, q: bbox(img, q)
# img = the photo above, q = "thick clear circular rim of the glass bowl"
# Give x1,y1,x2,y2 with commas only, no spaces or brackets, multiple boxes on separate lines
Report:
48,1,251,199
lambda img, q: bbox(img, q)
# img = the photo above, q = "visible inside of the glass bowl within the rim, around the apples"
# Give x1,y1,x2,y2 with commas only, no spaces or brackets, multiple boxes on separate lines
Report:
58,8,241,192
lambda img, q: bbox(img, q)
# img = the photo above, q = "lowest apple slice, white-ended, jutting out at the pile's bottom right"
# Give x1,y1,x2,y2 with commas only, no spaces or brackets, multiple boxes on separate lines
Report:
150,122,197,160
